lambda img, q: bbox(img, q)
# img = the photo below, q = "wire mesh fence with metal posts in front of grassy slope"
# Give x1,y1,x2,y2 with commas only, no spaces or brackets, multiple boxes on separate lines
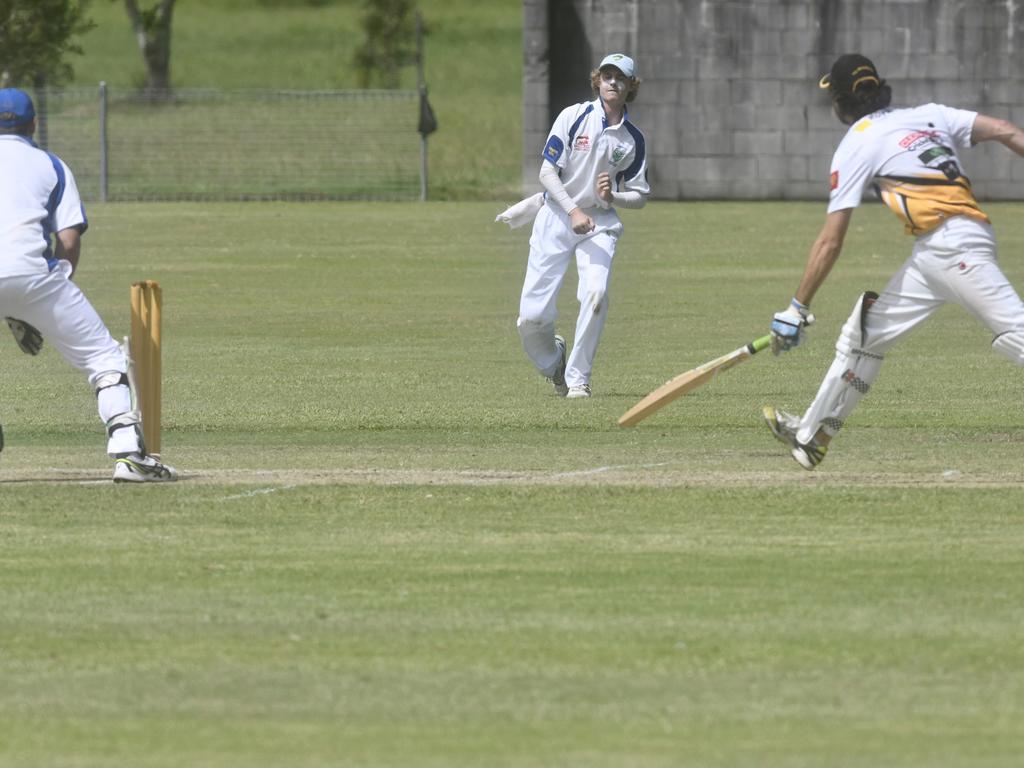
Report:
33,85,425,201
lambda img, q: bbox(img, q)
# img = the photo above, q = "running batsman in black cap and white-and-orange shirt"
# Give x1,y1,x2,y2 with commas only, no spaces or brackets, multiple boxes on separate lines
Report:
764,53,1024,469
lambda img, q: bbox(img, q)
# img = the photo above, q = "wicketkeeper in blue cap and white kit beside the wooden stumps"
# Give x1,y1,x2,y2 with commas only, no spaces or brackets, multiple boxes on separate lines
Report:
0,88,177,482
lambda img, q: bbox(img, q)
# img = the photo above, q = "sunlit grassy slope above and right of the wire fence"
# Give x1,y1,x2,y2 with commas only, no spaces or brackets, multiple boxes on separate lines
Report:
69,0,524,202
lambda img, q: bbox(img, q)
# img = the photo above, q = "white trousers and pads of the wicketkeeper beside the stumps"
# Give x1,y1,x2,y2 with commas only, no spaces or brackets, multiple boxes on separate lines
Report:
0,269,139,456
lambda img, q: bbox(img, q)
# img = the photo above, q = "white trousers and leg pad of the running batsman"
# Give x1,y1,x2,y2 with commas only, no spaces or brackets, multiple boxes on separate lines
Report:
797,216,1024,442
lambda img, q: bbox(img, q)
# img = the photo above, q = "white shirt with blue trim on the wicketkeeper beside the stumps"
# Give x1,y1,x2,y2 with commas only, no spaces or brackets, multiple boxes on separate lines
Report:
0,134,88,278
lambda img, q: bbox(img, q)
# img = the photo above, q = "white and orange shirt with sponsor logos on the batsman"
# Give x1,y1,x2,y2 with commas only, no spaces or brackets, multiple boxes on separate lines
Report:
828,103,988,236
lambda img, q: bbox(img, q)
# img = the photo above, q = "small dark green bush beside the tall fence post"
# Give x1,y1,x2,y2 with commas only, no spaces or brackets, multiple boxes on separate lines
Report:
352,0,416,88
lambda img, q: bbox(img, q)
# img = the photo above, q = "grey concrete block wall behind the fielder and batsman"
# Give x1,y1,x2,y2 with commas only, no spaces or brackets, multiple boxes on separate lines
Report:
523,0,1024,200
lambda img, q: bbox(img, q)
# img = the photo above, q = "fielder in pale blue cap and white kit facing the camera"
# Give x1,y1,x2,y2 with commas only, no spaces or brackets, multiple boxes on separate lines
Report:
517,53,650,397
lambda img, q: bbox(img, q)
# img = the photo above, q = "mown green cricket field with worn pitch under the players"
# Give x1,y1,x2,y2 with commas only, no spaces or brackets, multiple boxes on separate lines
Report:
0,201,1024,768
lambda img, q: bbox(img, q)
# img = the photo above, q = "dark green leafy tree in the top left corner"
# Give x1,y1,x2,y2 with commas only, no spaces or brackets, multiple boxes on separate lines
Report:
0,0,95,86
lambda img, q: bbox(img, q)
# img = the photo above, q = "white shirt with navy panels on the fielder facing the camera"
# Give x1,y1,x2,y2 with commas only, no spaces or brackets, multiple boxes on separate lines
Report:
543,99,650,214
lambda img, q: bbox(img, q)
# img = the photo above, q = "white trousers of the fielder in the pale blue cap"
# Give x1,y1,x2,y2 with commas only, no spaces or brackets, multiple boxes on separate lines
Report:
516,202,623,387
